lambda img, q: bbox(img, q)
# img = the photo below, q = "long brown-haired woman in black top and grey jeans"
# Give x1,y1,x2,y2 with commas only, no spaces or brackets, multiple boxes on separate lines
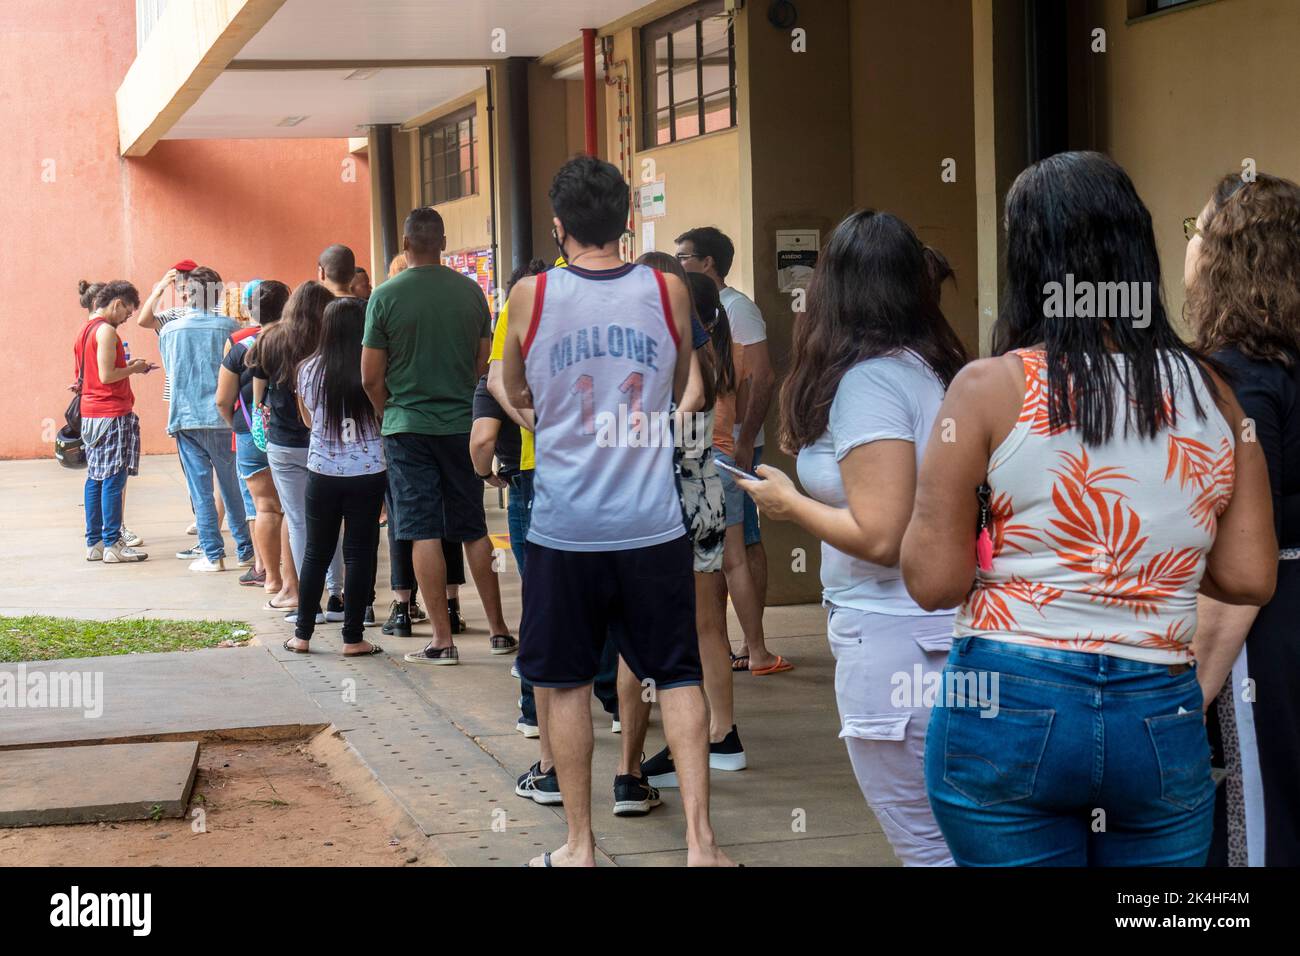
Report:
244,281,343,624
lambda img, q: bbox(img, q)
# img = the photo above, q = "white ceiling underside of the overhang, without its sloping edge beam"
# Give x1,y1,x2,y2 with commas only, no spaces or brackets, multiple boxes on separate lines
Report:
164,0,647,139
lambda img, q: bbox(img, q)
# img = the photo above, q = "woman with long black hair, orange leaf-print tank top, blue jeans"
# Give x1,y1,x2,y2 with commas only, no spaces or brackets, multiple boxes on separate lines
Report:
902,152,1277,866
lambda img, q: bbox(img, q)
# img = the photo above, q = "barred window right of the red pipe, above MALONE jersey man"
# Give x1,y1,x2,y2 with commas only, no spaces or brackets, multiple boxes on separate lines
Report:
641,0,736,148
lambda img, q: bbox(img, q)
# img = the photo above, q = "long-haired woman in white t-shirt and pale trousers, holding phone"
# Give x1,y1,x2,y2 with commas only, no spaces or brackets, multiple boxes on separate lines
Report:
740,209,966,866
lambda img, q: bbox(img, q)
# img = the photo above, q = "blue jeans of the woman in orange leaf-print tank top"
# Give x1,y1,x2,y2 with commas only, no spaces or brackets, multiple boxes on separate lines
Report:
926,637,1214,866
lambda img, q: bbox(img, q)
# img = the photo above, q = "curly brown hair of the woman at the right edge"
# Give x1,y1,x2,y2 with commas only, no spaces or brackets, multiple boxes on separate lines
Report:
1187,173,1300,368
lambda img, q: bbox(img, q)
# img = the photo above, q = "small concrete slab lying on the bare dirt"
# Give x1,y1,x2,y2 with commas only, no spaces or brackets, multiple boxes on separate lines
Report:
0,740,199,827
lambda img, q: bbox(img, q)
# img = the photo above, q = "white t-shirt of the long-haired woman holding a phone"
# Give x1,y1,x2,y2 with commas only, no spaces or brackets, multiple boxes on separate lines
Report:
798,351,952,617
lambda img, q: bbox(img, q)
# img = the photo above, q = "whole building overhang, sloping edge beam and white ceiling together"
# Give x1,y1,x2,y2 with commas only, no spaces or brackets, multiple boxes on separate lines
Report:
117,0,670,156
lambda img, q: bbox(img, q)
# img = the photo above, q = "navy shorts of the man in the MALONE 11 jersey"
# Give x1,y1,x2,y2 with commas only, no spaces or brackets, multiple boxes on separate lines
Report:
519,535,703,691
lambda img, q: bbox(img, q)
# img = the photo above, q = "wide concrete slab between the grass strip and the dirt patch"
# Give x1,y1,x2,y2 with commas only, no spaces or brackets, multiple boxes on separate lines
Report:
0,646,329,750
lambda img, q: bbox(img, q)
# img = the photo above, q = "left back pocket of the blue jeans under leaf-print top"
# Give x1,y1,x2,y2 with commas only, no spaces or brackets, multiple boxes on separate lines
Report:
944,708,1056,806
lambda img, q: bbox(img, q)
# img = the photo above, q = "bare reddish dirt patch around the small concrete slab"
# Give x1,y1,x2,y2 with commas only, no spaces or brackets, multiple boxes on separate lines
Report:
0,735,439,866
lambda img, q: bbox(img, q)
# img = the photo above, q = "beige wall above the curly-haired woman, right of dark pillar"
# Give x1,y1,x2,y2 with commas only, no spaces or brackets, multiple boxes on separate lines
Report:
1089,0,1300,330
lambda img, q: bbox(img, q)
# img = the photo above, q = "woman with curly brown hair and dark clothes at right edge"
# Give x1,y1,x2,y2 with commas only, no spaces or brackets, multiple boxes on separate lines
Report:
1183,173,1300,866
